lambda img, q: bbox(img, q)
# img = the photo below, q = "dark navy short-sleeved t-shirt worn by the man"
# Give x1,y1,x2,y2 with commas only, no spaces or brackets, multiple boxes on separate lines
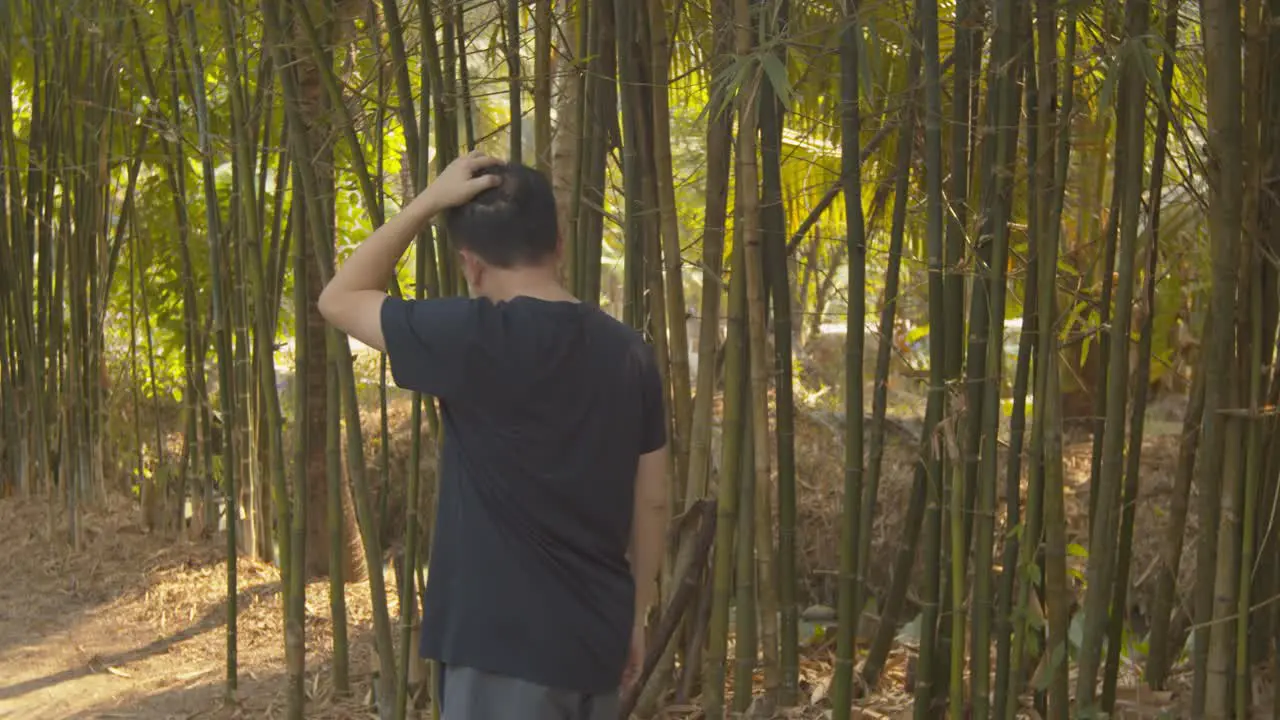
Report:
381,297,666,693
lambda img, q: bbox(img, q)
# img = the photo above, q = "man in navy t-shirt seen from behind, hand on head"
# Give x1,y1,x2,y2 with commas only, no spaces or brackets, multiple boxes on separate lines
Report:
320,152,667,720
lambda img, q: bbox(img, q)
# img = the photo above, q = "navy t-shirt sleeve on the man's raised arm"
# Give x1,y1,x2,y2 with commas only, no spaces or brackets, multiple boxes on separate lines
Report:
381,297,475,400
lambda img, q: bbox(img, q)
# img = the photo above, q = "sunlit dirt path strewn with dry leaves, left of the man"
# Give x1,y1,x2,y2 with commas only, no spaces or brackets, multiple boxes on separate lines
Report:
0,491,378,720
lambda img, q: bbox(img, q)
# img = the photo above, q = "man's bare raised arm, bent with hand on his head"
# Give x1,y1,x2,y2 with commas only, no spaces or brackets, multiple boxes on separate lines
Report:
319,151,502,351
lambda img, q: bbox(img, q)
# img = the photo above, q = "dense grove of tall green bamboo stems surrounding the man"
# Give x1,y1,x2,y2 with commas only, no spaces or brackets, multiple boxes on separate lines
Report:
0,0,1280,720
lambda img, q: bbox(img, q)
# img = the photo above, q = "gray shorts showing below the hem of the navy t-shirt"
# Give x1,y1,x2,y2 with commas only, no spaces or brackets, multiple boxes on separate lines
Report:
440,665,621,720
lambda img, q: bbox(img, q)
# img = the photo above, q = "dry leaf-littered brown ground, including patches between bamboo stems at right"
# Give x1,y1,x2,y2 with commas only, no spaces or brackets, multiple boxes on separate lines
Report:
0,394,1239,720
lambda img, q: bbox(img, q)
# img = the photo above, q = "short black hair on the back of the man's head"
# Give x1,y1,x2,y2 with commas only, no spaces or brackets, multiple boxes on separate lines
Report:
444,163,559,268
